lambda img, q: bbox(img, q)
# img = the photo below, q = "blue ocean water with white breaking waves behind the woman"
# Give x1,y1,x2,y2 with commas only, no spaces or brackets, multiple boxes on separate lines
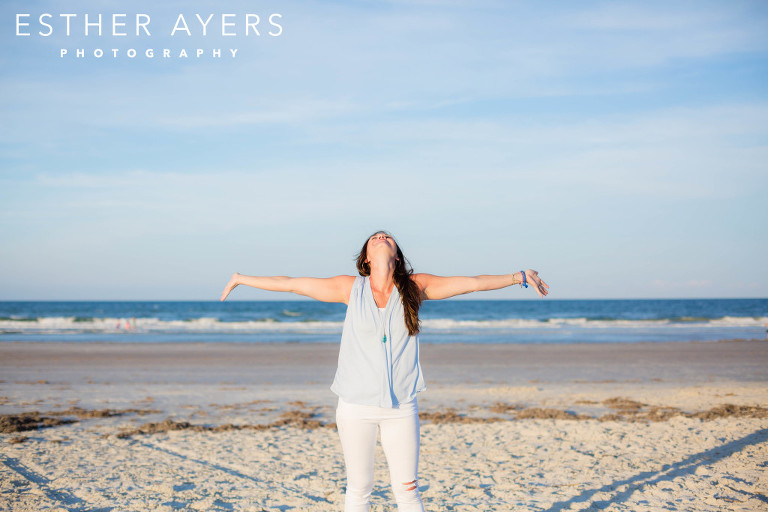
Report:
0,299,768,343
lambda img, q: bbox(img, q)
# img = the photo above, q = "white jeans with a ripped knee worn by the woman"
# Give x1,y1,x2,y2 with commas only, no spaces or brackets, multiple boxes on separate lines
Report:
336,398,424,512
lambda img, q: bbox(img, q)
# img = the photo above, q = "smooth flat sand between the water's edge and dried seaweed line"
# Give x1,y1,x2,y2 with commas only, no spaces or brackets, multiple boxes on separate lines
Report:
0,341,768,418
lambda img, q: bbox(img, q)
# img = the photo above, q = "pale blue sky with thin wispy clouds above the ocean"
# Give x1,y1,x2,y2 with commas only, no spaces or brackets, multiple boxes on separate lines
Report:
0,0,768,300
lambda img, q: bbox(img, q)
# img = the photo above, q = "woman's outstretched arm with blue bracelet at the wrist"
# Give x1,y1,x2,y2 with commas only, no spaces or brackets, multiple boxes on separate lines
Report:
413,269,549,300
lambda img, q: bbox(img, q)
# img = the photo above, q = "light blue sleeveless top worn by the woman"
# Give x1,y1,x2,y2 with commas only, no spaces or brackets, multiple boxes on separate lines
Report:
331,277,426,407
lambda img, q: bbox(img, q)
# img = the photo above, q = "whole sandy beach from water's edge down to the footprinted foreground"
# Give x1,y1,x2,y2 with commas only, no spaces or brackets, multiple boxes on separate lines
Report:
0,341,768,512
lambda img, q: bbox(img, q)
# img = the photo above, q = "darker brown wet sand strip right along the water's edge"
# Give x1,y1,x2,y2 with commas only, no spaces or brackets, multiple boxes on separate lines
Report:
0,339,768,372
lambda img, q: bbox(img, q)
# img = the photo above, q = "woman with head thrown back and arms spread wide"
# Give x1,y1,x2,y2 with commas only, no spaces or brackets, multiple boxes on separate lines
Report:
221,231,549,512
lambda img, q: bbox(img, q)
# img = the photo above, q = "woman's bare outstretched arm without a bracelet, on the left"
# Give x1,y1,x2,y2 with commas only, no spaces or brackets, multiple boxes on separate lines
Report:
221,273,355,304
